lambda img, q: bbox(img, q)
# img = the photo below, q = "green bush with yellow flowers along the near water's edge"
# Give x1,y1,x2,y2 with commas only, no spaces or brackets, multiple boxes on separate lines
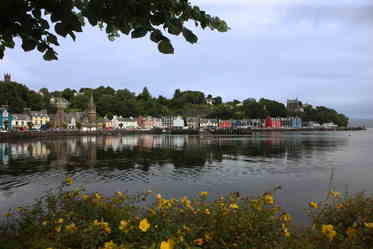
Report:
0,179,373,249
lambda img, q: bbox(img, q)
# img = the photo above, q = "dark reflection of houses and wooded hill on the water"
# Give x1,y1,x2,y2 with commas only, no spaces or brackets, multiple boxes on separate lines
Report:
0,133,347,189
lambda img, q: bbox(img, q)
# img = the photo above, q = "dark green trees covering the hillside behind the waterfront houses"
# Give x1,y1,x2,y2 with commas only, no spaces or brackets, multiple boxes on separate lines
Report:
0,81,348,126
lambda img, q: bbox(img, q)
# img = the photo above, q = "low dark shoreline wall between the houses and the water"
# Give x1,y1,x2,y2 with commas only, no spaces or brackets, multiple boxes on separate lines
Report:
0,127,367,141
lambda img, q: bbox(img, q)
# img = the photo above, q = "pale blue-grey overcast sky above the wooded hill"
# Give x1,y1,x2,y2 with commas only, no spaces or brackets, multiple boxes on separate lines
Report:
0,0,373,118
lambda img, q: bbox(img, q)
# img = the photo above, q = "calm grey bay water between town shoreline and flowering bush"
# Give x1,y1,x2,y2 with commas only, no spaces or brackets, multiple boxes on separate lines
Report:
0,129,373,220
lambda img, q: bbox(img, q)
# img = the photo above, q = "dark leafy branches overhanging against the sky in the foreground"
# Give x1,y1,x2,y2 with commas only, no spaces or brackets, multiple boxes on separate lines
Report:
0,0,228,60
